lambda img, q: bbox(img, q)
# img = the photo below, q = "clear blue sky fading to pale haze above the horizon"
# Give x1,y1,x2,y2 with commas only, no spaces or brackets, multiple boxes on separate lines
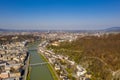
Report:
0,0,120,30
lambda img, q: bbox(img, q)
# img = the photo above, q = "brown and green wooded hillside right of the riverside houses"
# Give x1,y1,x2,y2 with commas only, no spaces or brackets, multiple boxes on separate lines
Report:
47,34,120,80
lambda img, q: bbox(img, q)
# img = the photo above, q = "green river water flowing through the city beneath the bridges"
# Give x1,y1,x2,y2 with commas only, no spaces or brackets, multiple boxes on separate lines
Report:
29,43,53,80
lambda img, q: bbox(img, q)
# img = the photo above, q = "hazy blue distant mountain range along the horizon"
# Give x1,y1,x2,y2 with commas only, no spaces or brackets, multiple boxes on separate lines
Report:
0,27,120,32
